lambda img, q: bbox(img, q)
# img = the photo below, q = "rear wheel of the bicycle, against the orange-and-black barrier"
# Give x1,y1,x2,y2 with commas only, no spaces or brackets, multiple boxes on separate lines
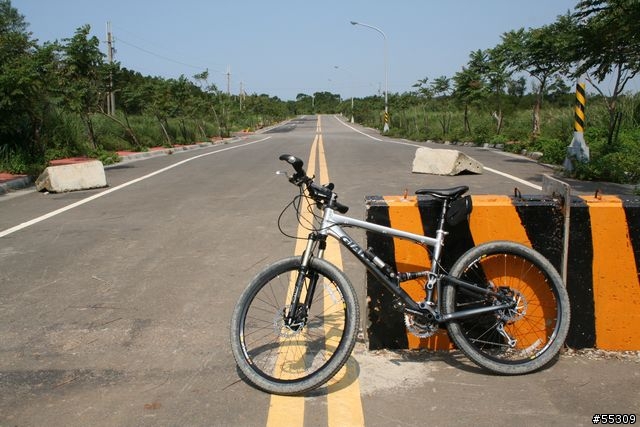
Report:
443,241,570,375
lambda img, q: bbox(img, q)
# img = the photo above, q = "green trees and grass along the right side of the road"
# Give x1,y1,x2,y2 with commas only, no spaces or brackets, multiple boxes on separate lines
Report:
341,0,640,184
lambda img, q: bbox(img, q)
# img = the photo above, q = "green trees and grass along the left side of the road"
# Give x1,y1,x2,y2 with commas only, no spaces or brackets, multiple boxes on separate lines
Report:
0,0,295,174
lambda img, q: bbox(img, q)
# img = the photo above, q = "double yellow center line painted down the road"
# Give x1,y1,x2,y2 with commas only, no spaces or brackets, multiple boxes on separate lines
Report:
267,116,364,427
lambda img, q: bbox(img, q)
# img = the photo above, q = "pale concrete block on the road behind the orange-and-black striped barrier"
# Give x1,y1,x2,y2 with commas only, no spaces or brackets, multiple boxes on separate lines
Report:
413,147,483,175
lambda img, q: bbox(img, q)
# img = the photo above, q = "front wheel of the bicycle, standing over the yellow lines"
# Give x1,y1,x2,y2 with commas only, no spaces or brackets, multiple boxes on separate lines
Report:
231,257,359,395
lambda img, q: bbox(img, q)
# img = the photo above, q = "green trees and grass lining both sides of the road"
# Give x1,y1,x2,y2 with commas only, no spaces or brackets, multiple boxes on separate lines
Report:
0,0,640,183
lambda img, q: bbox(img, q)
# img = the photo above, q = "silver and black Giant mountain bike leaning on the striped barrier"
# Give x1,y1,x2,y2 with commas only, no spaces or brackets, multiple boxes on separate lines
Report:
231,154,570,395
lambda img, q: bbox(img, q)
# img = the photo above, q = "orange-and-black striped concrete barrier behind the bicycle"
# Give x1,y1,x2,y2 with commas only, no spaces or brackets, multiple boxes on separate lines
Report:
366,195,640,350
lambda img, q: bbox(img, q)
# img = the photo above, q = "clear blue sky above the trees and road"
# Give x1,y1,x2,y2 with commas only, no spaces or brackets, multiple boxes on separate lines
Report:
12,0,592,99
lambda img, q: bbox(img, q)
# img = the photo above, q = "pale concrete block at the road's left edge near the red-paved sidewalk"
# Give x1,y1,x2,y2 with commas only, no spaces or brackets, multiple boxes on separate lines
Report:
36,160,107,193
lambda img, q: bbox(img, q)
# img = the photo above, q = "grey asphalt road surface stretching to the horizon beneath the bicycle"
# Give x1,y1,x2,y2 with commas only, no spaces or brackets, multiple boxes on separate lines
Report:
0,116,640,426
